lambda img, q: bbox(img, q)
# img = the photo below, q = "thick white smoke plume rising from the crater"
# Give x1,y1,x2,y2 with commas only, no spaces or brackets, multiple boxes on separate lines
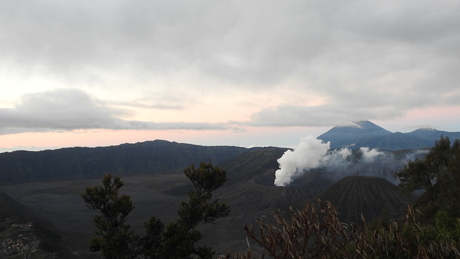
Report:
275,136,383,186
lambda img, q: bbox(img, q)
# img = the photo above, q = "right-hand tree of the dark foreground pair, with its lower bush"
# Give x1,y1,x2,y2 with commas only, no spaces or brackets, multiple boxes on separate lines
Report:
143,162,230,259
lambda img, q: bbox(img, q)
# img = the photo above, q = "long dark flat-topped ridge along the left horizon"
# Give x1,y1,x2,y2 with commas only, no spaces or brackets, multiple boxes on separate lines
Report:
0,140,248,184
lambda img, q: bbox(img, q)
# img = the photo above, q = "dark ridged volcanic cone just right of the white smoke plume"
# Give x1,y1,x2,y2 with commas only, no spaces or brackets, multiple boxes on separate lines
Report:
319,176,412,223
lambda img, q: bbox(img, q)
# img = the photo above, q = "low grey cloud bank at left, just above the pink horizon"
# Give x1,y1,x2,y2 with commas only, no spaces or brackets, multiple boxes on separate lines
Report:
0,89,227,134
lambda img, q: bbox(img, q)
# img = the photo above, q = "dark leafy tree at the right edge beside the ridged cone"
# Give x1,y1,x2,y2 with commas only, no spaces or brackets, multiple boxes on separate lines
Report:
395,137,460,221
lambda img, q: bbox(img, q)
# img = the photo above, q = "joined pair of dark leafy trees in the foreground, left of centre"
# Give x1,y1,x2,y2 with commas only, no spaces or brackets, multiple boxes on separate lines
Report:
82,163,230,259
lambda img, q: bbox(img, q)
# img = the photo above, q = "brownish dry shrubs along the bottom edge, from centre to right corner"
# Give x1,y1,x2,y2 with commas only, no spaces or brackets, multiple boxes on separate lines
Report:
227,200,460,259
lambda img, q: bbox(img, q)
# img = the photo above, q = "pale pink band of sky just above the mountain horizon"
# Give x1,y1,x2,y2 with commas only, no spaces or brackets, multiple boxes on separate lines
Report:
0,104,460,151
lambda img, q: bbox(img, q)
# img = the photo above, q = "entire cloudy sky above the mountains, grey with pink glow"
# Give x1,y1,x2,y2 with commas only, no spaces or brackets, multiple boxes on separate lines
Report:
0,0,460,152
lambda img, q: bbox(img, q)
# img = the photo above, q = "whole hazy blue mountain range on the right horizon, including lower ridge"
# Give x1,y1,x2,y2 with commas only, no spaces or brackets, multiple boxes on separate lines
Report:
318,121,460,151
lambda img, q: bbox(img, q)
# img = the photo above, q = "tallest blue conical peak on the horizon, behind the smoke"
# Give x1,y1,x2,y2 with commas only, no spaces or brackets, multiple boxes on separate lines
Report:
318,121,391,148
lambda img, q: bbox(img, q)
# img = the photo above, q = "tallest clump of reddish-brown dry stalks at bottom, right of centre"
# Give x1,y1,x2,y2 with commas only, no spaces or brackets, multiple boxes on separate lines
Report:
232,199,351,259
